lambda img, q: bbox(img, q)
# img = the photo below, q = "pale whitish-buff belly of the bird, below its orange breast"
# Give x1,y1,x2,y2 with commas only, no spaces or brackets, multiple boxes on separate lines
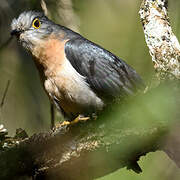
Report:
44,57,104,114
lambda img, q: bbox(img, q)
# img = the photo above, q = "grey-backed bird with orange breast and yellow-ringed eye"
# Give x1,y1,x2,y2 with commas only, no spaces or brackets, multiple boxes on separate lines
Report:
11,11,144,125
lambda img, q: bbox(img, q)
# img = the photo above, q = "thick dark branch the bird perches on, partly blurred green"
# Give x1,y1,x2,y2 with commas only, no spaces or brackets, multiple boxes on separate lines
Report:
0,83,179,180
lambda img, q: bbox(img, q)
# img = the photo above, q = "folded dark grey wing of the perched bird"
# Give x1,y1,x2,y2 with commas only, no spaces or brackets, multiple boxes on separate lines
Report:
65,37,144,99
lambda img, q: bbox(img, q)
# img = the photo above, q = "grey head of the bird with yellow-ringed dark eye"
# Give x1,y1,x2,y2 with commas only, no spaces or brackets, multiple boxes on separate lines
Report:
11,11,54,51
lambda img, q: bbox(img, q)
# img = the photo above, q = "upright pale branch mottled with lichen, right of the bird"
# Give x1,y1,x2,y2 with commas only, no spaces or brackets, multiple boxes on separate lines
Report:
139,0,180,80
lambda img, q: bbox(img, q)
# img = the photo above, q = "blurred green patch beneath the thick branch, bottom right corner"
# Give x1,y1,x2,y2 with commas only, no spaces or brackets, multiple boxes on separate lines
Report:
98,151,180,180
